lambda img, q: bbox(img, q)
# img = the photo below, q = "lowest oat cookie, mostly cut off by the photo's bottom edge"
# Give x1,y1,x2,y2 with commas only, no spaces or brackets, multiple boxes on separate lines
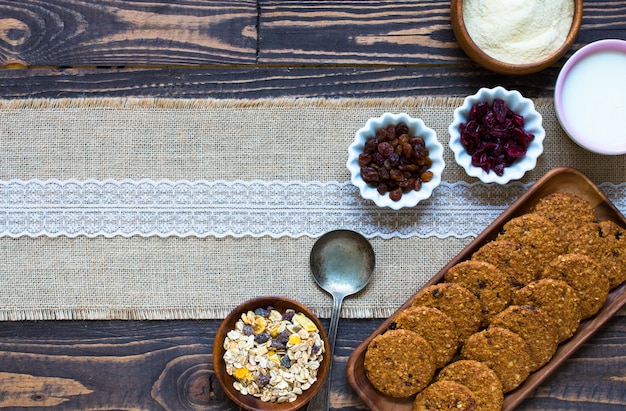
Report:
413,380,478,411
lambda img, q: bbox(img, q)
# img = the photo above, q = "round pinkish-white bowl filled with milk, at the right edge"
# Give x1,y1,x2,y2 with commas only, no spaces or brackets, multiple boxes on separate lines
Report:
554,39,626,155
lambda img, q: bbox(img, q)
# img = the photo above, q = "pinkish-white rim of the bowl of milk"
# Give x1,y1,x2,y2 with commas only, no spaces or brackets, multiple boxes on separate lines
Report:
554,39,626,155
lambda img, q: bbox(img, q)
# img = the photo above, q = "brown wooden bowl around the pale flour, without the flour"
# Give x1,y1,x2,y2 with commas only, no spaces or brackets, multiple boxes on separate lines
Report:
450,0,583,75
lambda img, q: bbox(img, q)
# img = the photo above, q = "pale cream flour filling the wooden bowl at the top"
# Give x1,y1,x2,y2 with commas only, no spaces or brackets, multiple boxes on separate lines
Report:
463,0,574,64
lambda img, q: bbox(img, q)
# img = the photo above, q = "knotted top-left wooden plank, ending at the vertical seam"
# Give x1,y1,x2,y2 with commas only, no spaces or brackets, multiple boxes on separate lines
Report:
0,0,258,67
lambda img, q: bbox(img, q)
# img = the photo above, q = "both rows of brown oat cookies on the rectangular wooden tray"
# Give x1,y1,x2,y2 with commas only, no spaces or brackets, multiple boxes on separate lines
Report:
366,193,626,410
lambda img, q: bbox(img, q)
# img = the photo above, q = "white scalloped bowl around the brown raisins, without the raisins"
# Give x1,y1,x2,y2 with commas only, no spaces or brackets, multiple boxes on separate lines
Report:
346,113,445,210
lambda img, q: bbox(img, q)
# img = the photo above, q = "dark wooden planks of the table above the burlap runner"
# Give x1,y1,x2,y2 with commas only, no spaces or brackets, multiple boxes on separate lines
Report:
0,0,626,98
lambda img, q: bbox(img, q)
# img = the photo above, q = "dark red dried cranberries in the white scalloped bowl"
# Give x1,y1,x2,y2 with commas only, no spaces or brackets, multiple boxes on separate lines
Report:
459,99,535,176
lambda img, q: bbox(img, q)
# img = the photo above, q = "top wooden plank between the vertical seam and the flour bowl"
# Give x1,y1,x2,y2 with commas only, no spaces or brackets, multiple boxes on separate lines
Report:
259,0,458,66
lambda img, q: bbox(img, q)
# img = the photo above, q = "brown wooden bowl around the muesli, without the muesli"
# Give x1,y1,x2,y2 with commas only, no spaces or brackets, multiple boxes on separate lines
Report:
213,296,330,411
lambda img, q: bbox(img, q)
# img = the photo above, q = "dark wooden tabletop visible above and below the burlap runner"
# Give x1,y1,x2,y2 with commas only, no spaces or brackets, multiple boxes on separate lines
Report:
0,0,626,410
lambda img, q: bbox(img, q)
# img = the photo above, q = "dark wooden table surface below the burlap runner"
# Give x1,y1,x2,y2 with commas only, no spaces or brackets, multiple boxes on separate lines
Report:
0,318,626,411
